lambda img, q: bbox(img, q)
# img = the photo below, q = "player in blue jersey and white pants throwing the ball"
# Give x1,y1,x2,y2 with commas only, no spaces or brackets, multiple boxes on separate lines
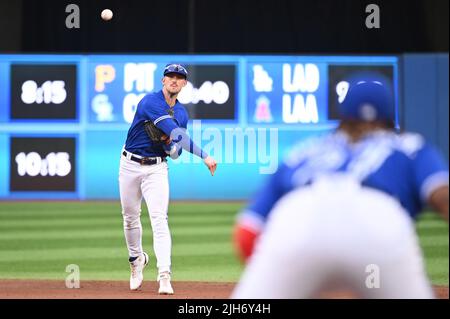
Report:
119,64,217,294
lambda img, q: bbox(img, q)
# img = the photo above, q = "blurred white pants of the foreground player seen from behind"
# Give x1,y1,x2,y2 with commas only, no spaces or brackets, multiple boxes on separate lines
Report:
231,176,433,299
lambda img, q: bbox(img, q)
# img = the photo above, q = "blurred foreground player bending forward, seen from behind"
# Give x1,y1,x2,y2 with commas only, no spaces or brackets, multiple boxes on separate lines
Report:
232,75,449,298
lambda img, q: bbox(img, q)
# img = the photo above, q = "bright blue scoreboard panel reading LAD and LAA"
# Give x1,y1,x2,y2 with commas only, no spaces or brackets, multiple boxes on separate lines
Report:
247,60,328,125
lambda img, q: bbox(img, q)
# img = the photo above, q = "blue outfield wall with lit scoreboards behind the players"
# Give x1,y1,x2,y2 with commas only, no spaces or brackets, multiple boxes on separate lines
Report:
0,54,448,200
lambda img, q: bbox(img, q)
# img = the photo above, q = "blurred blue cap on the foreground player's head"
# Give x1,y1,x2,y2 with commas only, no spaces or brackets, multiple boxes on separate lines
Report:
339,73,395,123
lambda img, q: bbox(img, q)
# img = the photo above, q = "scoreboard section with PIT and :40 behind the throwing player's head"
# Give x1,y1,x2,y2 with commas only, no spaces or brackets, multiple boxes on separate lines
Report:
89,60,237,123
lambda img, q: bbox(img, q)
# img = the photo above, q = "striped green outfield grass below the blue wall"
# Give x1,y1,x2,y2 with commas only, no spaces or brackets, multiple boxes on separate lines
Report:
0,202,449,286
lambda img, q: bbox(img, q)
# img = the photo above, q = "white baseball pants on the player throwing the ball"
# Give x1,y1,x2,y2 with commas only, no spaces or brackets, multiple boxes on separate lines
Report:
119,155,172,272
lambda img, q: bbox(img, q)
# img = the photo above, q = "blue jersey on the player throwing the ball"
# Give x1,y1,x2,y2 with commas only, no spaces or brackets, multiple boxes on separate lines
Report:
125,90,189,157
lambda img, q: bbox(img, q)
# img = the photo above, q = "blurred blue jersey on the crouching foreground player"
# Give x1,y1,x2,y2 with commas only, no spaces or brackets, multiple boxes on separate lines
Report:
240,131,449,228
